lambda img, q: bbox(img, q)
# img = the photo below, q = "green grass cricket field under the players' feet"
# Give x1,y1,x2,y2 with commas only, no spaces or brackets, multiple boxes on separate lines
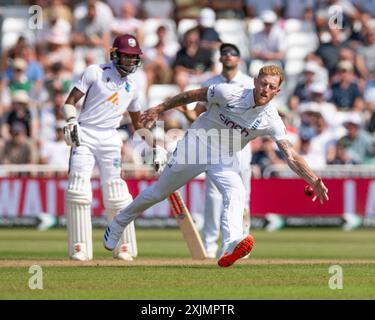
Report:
0,229,375,300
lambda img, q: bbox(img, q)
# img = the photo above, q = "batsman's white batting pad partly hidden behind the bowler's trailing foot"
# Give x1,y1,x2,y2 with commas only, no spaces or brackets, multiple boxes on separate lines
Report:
102,179,138,260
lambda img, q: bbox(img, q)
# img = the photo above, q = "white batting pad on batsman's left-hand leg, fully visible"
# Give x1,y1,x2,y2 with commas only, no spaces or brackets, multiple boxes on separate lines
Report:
65,172,93,260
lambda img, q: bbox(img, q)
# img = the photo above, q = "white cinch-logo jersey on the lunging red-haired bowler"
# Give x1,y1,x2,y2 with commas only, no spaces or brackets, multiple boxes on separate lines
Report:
191,83,287,151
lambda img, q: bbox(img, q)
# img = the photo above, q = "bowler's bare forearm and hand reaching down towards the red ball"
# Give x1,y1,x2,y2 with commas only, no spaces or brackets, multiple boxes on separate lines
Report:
276,140,328,204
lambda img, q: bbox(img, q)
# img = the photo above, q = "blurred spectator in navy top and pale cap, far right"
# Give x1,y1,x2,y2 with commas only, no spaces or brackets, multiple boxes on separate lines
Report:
330,60,364,112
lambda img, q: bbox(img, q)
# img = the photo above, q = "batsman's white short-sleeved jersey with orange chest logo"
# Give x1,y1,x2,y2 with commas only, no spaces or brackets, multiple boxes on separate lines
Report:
75,63,141,129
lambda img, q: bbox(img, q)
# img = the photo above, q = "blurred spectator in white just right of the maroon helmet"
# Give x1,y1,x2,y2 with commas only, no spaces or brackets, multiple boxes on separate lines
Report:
144,25,179,86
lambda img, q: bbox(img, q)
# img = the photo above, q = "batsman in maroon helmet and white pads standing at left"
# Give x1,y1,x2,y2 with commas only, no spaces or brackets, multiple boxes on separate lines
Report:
63,34,166,260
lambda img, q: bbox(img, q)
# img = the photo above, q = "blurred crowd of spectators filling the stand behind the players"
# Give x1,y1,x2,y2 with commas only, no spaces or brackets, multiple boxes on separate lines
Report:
0,0,375,175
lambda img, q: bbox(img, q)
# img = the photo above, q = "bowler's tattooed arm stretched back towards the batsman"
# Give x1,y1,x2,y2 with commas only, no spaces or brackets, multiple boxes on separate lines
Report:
141,87,208,128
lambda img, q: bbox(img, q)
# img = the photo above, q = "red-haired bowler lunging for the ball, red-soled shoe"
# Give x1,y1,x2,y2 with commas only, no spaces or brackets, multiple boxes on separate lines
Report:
103,65,328,267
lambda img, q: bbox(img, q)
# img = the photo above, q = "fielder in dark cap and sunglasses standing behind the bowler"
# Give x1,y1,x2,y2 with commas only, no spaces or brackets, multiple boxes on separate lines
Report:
185,43,254,258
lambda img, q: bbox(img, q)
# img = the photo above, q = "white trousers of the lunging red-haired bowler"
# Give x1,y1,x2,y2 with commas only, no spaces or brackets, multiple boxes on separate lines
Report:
116,140,245,250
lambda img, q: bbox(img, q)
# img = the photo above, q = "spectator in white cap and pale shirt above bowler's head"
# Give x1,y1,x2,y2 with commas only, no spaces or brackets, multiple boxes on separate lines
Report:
250,10,287,65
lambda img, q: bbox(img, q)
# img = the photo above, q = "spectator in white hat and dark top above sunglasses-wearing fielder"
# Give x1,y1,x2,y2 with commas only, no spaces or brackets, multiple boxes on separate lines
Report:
198,8,221,54
